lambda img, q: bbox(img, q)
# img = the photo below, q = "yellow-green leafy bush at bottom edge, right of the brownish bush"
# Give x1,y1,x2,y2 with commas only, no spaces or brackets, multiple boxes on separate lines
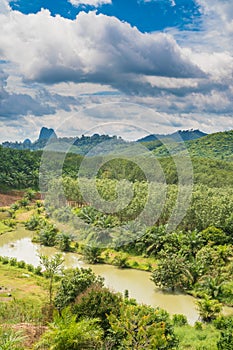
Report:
107,304,178,350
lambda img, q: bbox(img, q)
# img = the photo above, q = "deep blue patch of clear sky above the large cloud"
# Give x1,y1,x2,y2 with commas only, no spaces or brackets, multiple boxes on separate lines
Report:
10,0,200,32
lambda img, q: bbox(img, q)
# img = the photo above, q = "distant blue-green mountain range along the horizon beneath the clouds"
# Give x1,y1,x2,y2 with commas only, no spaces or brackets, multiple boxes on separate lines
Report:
2,127,233,161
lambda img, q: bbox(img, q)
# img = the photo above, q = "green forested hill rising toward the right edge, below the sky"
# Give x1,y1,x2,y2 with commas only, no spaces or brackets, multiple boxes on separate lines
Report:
143,130,233,161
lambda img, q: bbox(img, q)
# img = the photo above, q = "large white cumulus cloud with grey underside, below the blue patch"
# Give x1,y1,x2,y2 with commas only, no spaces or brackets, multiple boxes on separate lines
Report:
0,9,203,89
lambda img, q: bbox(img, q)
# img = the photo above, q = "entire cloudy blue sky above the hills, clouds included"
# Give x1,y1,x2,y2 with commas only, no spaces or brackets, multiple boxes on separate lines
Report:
0,0,233,142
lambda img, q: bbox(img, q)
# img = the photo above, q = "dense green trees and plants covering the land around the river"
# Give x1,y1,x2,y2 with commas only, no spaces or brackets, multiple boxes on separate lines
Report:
0,131,233,350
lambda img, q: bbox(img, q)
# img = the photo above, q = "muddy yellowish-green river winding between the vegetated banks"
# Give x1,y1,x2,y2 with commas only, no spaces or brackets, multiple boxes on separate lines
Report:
0,228,233,324
